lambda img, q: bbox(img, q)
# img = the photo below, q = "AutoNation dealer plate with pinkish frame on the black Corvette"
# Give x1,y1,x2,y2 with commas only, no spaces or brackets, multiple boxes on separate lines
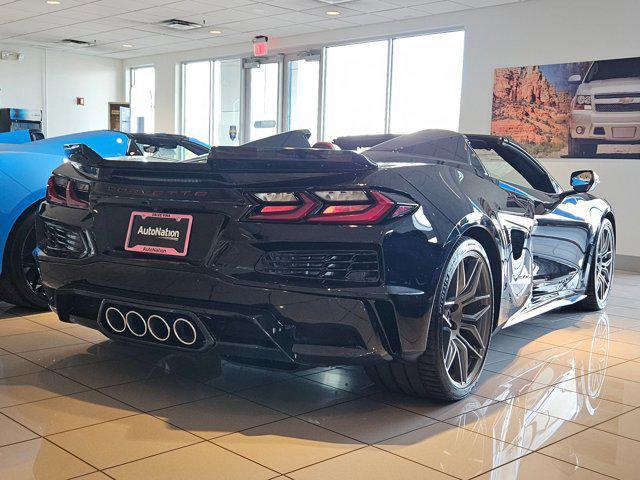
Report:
124,212,193,257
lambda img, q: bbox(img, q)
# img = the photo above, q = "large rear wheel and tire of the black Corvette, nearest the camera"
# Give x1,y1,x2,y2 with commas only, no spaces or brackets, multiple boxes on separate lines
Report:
365,237,495,401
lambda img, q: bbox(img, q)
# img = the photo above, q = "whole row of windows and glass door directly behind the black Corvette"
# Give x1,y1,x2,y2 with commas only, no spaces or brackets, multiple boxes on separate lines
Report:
182,31,464,145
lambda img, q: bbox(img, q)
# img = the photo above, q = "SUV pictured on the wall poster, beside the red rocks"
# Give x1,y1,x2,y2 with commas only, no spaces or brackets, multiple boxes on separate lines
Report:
565,57,640,157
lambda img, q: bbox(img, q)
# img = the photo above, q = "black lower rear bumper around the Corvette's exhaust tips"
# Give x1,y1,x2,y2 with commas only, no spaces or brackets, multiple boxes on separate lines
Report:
39,253,440,365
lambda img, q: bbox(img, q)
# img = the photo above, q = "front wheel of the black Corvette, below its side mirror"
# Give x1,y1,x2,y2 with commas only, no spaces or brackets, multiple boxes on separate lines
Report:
578,218,616,312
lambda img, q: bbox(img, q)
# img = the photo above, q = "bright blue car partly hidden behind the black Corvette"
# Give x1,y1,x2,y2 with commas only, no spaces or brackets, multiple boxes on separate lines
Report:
0,130,210,308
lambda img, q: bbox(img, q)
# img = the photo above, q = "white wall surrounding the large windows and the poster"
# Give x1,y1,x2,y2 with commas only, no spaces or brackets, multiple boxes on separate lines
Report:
125,0,640,257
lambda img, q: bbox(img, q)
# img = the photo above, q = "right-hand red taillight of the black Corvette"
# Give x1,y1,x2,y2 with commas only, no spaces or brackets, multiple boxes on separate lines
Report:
246,190,417,225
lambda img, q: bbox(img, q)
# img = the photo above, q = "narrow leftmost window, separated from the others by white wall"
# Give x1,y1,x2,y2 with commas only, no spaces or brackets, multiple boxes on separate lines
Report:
129,67,156,133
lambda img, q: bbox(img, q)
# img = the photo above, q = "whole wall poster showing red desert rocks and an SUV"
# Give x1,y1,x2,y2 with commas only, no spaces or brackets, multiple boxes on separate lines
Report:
491,57,640,158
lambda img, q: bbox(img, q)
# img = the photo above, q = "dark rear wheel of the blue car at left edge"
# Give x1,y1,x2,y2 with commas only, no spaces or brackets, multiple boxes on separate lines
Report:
0,210,48,310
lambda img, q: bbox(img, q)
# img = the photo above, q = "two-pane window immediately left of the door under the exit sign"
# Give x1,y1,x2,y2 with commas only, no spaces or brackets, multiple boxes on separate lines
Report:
182,59,242,145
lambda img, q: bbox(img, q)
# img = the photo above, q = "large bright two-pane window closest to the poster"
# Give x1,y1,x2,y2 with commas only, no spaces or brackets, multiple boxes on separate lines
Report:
322,31,464,140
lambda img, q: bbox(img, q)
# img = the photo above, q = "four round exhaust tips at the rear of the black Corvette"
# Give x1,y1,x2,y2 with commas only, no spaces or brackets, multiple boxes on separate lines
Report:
104,307,198,347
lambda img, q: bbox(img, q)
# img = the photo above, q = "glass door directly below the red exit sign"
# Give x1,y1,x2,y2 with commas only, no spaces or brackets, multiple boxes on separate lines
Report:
245,58,282,141
